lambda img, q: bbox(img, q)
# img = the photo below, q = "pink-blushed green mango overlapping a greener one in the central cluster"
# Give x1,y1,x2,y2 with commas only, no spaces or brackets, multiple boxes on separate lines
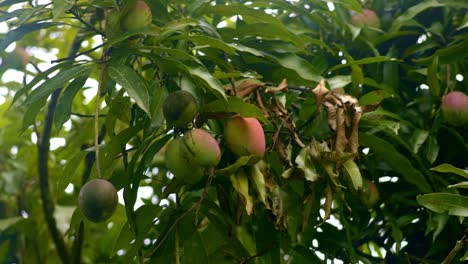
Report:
183,129,221,168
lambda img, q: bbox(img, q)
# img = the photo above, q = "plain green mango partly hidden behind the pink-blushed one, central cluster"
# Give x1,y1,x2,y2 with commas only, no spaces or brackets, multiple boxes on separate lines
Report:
165,137,204,184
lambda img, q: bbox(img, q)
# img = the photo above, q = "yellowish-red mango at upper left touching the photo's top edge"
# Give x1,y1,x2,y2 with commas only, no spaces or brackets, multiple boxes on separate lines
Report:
122,1,153,31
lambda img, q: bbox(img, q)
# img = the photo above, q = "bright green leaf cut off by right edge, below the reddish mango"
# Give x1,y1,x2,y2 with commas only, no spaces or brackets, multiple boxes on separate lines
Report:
416,193,468,217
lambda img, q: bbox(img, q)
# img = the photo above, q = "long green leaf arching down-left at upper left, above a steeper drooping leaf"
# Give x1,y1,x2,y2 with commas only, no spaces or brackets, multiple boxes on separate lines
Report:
23,65,94,105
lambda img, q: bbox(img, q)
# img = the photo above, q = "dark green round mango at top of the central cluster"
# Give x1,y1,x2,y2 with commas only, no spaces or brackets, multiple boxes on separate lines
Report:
163,90,198,128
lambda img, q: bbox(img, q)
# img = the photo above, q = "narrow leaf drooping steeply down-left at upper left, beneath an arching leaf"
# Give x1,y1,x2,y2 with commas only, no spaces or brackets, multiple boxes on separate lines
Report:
54,75,91,131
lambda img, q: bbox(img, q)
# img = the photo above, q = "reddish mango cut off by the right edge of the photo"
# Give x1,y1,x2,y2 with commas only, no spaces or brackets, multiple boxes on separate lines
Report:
441,91,468,126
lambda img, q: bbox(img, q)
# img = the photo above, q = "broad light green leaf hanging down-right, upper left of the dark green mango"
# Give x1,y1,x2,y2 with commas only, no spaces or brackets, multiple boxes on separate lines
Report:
107,64,151,116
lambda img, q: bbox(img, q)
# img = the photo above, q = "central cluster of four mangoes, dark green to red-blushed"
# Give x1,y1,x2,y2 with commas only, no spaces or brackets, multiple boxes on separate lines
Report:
163,90,265,184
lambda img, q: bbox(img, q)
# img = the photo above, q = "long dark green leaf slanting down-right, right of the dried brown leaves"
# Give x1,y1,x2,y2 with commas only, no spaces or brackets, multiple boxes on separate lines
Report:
359,133,432,192
